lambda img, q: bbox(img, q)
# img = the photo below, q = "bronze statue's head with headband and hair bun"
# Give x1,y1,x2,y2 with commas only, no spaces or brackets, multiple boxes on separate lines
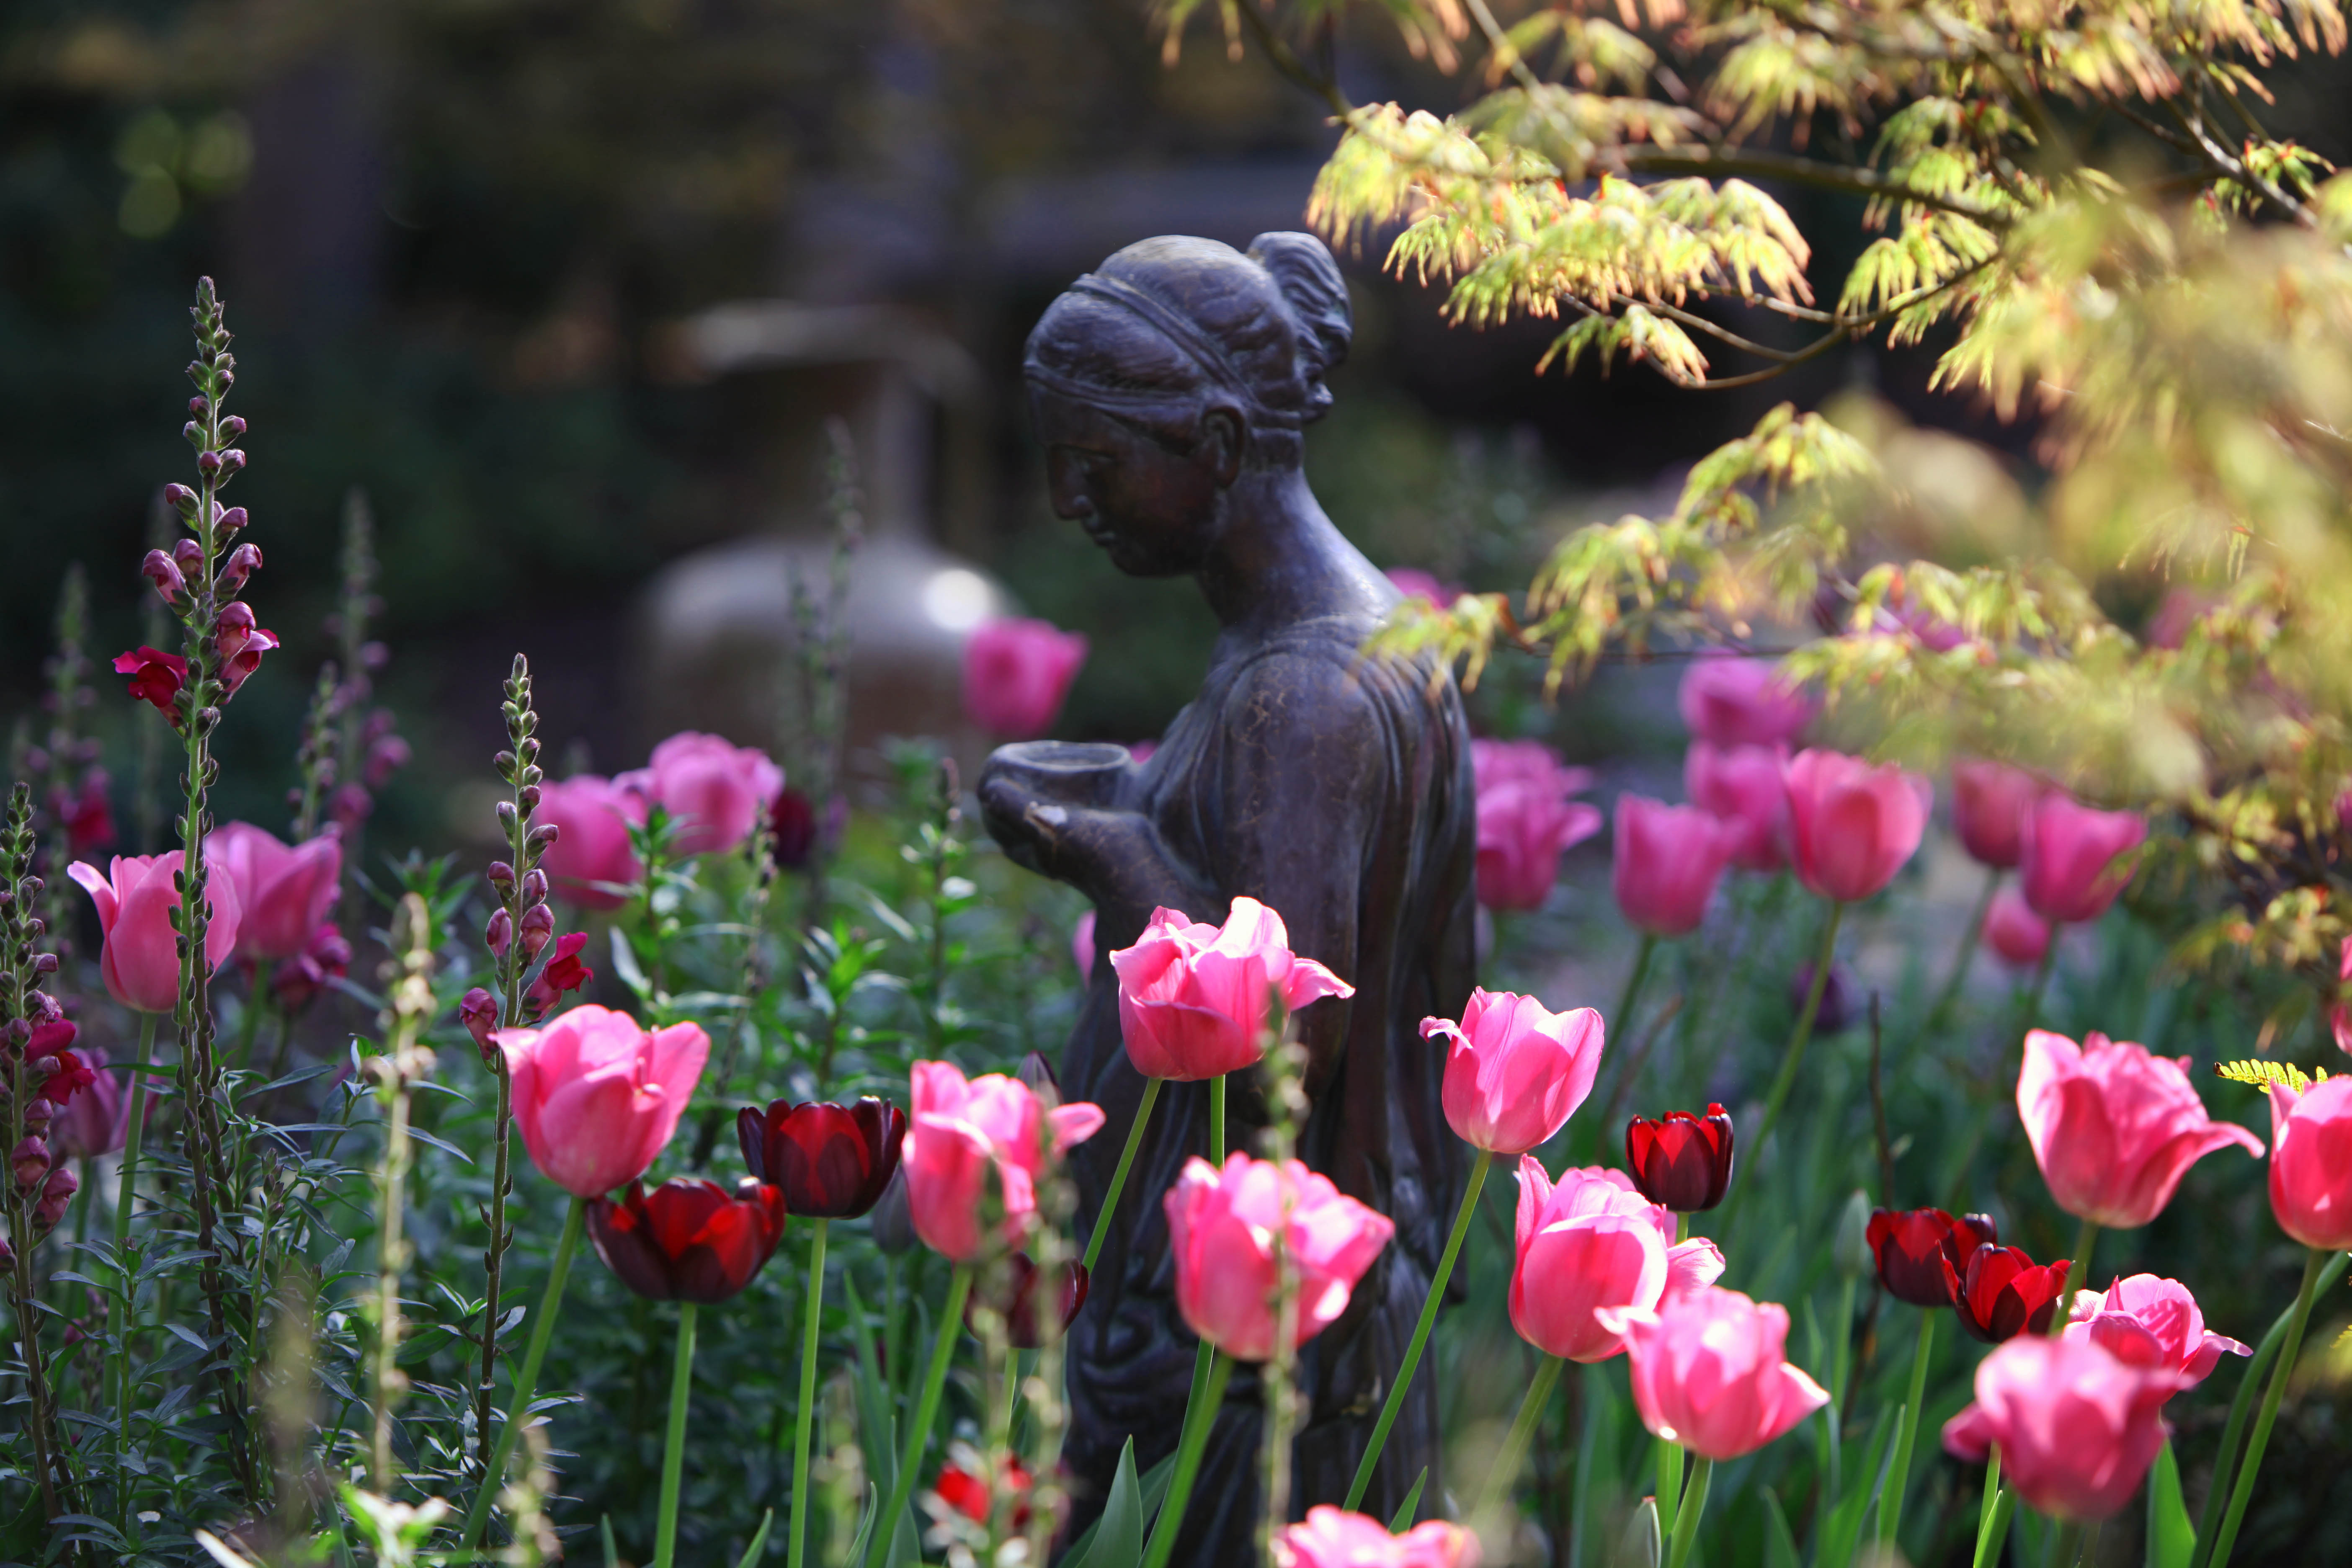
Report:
1021,233,1350,576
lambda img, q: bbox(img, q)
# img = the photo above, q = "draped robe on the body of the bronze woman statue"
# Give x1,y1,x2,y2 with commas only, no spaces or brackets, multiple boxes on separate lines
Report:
1061,616,1477,1568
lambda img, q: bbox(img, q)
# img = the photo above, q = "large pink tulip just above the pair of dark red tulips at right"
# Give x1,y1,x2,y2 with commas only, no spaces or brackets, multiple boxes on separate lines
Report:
2018,1030,2263,1230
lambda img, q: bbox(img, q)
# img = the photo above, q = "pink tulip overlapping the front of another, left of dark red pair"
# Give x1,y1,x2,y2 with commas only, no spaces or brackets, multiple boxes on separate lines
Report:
1599,1286,1830,1460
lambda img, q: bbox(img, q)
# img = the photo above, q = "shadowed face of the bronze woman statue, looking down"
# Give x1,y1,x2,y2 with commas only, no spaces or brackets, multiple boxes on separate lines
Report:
1030,390,1233,576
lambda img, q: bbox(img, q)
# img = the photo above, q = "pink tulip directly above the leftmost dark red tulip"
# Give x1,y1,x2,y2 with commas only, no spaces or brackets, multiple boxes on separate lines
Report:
492,1004,710,1199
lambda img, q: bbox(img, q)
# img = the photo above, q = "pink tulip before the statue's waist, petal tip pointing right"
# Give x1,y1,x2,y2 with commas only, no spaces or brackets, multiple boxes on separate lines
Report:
1110,898,1355,1084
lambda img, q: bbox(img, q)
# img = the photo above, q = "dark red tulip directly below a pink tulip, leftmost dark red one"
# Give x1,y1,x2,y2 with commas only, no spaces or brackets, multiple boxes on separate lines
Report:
588,1178,786,1307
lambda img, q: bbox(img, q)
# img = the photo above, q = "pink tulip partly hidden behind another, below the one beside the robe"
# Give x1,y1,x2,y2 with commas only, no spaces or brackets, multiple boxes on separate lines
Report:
1510,1157,1724,1361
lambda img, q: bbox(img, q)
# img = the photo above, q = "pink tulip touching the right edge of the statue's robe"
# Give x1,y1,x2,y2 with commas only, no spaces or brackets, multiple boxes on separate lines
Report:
1421,990,1604,1154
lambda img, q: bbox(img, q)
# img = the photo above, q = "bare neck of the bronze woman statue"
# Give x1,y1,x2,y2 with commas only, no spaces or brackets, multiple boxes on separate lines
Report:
1199,468,1395,640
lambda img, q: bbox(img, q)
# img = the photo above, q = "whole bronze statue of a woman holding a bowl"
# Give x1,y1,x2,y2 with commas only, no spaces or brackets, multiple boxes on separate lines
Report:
981,233,1475,1568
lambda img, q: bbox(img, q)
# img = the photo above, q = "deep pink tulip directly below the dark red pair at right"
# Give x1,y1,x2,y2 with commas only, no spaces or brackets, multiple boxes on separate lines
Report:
1943,1333,2187,1519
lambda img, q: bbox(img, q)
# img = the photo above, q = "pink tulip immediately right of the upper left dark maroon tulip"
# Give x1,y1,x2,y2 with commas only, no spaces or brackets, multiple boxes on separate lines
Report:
901,1063,1103,1262
